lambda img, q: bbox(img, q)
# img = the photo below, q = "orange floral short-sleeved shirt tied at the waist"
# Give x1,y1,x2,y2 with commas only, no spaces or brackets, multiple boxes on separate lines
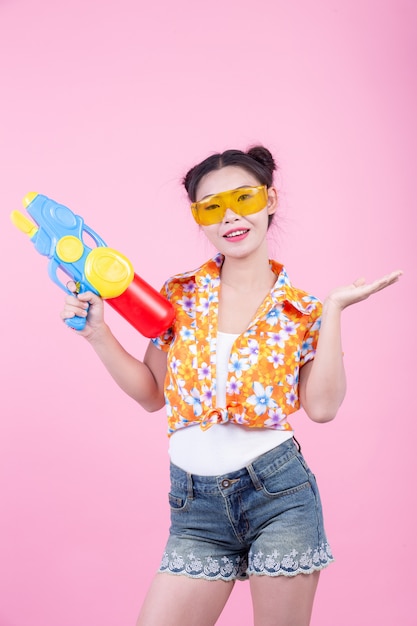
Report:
152,254,322,435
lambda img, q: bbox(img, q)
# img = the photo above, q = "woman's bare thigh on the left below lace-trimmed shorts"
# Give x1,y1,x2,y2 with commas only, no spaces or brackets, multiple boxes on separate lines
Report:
136,574,234,626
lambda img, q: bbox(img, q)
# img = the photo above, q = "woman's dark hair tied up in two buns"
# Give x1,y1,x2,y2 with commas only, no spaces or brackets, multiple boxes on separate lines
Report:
182,146,276,202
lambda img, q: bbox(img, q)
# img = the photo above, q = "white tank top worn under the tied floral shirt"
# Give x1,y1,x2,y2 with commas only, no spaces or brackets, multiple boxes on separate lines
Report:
169,332,293,476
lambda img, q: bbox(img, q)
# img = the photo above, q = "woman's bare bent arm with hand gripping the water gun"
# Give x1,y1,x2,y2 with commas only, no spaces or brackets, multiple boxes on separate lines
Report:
61,285,167,411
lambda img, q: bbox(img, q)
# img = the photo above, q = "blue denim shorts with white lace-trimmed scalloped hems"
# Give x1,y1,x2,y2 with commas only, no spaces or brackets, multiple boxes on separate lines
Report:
159,439,333,581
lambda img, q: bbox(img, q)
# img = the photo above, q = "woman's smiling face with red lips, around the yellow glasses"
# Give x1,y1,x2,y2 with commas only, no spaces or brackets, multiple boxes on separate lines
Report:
196,165,278,257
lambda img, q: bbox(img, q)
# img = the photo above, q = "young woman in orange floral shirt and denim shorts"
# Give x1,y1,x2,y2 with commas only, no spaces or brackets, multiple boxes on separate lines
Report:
61,146,401,626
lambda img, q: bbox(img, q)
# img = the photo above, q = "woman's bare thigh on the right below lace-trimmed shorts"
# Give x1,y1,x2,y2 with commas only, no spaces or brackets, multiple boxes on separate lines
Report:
250,571,320,626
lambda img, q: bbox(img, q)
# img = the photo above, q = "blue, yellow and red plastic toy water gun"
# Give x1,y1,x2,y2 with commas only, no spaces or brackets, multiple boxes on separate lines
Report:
10,192,174,337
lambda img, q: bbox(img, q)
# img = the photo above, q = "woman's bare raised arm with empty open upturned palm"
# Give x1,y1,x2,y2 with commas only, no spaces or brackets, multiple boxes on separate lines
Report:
300,271,402,422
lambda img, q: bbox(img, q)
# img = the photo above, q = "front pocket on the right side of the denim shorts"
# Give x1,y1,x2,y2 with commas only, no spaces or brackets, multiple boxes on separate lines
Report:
260,456,311,498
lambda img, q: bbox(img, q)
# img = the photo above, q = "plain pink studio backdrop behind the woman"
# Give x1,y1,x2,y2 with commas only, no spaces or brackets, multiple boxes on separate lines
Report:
0,0,417,626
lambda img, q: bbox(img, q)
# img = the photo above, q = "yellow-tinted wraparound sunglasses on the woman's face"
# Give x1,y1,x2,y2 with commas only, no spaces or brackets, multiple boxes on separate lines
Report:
191,185,268,226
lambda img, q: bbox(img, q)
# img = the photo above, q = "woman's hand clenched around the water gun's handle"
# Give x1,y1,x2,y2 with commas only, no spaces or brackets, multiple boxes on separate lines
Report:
61,281,106,339
